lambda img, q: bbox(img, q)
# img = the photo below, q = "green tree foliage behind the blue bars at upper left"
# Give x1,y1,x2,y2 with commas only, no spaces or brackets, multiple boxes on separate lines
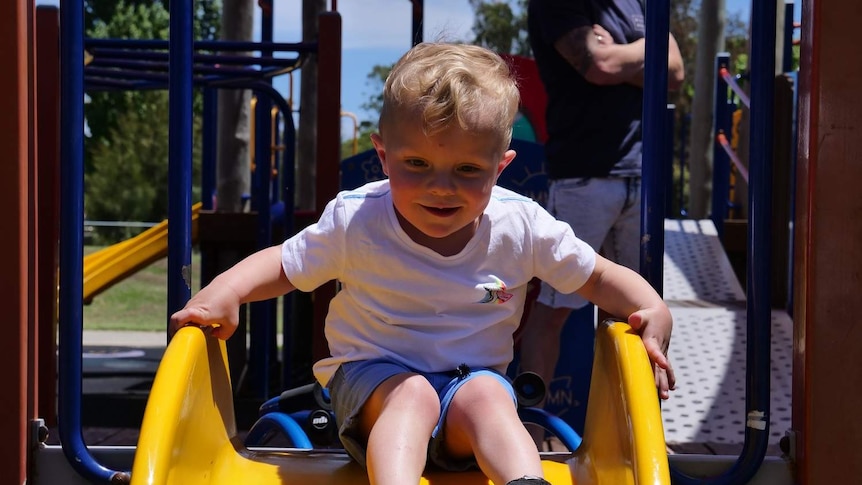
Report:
84,0,221,242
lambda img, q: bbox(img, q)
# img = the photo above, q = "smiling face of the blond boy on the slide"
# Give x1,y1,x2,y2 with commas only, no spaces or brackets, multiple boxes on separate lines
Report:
371,118,515,254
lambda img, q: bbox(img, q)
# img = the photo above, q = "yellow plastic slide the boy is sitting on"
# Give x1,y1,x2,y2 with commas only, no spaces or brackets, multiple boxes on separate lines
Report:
131,323,670,485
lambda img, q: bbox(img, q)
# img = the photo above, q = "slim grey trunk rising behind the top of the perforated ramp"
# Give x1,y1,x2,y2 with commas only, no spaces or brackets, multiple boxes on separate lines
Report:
688,0,726,219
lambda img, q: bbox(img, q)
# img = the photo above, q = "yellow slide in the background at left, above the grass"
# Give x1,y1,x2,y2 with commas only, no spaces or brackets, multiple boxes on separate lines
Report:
84,202,201,302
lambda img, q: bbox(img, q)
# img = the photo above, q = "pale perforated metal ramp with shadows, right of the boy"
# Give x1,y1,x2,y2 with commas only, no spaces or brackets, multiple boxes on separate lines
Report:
662,220,793,444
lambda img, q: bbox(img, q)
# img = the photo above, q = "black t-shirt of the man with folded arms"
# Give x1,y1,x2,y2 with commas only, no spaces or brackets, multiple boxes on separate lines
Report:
528,0,645,179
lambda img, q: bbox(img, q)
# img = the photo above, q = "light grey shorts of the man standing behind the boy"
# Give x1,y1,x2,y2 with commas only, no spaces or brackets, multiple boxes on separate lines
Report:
538,177,641,309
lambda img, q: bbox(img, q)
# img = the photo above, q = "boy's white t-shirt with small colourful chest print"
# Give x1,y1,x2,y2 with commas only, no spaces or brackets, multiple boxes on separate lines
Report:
282,180,596,385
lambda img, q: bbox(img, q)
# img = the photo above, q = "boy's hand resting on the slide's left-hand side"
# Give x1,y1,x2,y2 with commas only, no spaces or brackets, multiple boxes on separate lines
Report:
170,283,240,340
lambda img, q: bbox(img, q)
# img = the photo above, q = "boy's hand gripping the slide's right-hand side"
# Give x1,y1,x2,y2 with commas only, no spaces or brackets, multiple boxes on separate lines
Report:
628,308,676,399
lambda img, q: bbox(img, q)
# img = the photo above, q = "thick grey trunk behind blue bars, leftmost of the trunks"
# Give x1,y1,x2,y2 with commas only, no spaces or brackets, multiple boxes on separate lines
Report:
216,0,256,212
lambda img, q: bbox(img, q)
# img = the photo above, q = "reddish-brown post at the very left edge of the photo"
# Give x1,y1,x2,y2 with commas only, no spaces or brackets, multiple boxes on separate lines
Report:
0,0,33,483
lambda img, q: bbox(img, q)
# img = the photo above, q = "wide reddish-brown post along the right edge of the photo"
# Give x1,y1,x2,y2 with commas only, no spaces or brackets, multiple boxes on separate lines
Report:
793,0,862,485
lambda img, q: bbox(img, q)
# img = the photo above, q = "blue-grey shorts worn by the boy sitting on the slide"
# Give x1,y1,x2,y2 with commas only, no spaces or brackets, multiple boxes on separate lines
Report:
328,359,517,471
